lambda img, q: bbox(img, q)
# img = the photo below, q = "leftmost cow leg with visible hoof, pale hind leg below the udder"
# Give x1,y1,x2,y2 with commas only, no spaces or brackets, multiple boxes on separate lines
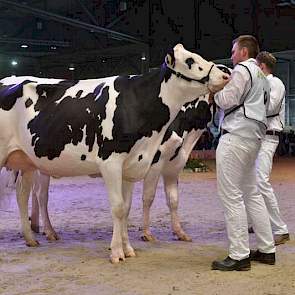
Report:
16,171,39,247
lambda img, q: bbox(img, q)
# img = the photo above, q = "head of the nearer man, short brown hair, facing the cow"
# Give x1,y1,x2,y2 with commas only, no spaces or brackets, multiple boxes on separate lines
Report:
231,35,259,66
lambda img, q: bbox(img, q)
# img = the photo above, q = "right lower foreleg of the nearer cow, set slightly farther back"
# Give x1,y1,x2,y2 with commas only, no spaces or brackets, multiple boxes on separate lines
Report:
122,181,136,257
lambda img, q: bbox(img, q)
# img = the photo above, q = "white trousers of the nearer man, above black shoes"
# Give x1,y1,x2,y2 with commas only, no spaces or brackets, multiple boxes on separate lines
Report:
216,133,275,260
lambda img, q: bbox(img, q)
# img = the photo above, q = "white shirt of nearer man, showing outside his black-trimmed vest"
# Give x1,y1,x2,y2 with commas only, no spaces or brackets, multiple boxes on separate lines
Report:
214,58,266,139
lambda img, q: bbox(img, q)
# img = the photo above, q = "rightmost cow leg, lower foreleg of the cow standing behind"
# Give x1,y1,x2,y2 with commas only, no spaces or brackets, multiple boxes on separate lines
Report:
163,175,192,242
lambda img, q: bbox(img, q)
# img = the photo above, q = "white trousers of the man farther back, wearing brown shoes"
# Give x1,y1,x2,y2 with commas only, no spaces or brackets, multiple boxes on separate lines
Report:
256,135,288,235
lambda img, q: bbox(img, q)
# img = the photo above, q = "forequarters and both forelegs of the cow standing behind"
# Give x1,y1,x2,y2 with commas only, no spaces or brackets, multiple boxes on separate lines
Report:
142,65,231,241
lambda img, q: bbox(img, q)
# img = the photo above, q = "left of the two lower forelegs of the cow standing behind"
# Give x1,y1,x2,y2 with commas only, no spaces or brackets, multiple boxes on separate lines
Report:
141,168,160,242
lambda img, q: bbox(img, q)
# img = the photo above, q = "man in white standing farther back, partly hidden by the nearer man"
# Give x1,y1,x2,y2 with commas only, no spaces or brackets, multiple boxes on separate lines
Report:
254,51,290,245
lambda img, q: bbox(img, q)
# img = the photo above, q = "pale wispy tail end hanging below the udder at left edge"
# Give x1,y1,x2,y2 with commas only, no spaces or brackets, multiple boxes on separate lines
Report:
0,167,17,208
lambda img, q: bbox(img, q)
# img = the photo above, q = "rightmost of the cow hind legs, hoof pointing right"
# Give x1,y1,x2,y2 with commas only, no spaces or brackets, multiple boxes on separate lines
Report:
32,171,59,241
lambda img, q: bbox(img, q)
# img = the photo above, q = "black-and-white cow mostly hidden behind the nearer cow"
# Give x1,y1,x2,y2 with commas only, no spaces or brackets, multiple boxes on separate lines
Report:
25,65,231,245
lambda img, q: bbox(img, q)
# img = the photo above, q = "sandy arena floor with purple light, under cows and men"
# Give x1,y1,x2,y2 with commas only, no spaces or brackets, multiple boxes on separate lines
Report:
0,158,295,295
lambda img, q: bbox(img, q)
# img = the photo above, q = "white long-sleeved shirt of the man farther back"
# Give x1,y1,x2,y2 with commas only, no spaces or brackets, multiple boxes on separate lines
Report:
267,74,285,131
